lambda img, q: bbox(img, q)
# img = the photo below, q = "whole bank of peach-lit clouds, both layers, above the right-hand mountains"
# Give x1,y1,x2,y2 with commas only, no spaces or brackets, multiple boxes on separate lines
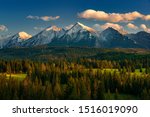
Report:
77,9,150,34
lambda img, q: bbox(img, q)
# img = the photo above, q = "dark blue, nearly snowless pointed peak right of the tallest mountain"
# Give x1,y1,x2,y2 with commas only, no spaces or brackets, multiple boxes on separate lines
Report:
99,28,140,48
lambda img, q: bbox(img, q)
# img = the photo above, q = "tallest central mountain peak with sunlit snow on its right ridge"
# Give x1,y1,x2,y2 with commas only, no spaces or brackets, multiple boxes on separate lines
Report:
52,22,98,47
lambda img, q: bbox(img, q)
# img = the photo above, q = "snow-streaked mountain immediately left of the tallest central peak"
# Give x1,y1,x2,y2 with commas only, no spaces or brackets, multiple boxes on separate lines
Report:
22,26,65,46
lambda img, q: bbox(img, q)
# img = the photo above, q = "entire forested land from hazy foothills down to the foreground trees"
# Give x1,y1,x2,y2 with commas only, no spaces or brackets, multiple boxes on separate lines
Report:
0,47,150,100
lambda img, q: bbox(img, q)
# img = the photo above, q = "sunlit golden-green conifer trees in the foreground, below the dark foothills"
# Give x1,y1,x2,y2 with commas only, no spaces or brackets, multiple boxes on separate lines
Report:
0,57,150,100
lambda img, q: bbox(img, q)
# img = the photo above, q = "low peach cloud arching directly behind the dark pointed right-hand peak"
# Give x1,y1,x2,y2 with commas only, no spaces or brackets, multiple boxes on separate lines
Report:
94,23,127,34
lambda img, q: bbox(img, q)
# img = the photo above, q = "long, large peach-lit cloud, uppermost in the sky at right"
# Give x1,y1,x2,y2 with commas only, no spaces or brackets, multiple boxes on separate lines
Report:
78,9,150,22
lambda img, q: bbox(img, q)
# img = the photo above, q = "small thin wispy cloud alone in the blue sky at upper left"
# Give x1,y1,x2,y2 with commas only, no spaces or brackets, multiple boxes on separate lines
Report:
27,15,60,21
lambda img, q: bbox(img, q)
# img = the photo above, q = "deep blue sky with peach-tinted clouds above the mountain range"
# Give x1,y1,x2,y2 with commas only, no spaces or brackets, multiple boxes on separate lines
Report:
0,0,150,35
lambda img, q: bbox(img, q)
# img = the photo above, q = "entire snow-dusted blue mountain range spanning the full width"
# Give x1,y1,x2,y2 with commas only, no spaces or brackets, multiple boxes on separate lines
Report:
0,22,150,49
